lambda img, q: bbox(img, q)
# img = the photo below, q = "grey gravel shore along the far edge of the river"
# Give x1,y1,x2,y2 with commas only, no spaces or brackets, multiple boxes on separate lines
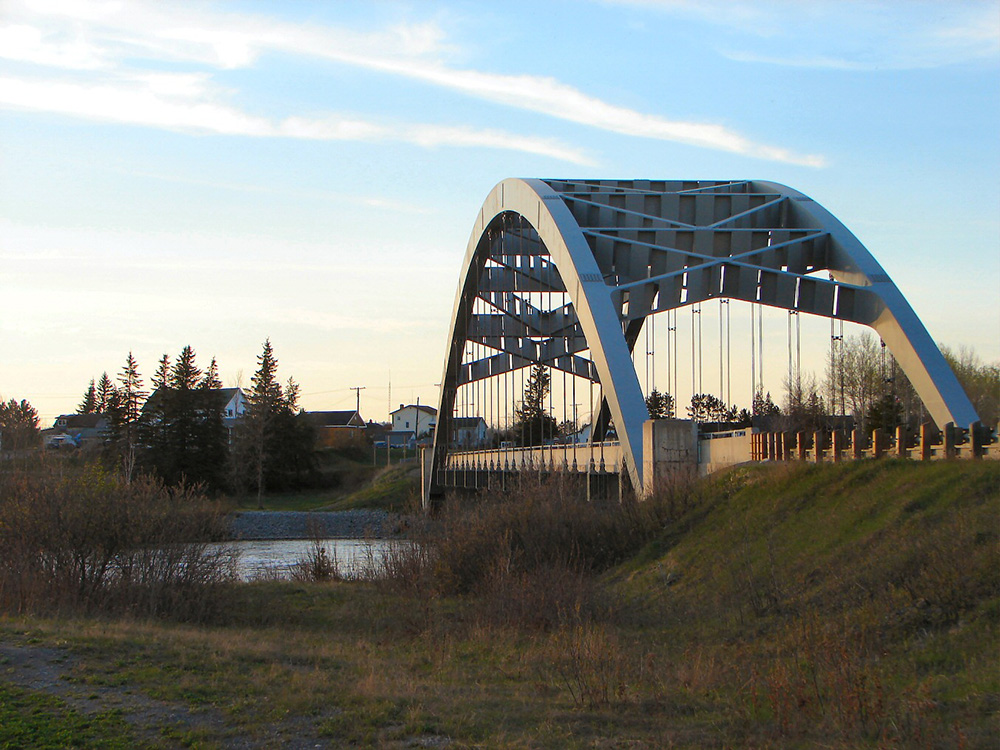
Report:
230,510,404,539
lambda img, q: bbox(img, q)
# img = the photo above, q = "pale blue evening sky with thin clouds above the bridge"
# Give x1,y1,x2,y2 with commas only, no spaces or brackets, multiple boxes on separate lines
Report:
0,0,1000,426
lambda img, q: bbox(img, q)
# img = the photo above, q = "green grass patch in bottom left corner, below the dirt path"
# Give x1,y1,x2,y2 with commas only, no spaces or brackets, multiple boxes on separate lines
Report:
0,681,136,750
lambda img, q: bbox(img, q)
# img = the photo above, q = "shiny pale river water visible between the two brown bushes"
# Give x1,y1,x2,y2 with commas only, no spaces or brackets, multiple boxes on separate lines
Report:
214,539,411,581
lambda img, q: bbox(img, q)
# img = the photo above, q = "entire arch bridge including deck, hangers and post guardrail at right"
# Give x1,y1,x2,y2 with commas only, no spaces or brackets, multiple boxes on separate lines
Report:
424,179,993,503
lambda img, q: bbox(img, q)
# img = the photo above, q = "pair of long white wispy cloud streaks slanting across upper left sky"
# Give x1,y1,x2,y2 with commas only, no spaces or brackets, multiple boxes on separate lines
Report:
0,0,825,166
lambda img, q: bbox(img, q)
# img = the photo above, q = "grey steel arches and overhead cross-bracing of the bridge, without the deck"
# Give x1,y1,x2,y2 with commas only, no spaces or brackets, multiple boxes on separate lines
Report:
432,179,978,500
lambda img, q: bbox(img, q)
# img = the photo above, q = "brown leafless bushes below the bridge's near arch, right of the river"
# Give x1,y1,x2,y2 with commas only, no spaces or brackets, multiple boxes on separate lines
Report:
382,476,694,630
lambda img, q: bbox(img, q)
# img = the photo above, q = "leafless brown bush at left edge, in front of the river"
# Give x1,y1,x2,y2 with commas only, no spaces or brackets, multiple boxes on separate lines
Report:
0,465,235,620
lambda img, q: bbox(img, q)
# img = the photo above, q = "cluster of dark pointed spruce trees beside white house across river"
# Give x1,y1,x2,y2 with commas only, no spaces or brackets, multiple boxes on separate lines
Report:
77,341,315,498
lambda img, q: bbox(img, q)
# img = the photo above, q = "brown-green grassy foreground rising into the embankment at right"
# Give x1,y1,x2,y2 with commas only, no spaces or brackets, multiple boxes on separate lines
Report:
0,461,1000,748
